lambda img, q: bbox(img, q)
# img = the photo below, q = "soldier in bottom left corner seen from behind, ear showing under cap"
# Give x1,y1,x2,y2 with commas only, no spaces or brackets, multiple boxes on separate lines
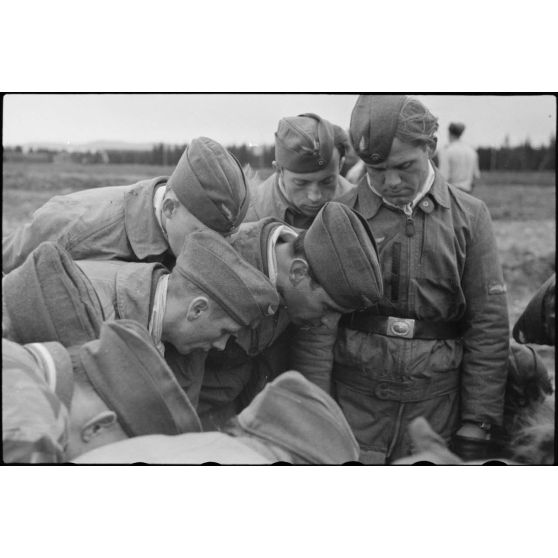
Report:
2,320,201,463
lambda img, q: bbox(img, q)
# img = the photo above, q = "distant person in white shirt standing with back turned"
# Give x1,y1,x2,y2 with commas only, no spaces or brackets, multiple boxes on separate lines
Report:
438,122,480,192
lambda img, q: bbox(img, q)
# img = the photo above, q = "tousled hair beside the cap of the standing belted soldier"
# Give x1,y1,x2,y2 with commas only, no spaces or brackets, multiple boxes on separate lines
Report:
395,97,438,150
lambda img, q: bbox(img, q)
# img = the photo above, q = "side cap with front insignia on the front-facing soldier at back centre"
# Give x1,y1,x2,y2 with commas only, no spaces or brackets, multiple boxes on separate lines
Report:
275,113,335,173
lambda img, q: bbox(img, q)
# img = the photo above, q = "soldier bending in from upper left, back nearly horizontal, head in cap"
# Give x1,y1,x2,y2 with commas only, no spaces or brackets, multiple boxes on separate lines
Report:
2,137,248,273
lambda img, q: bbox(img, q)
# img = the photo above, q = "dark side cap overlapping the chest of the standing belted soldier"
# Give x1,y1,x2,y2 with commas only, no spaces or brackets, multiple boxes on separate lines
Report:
304,202,383,310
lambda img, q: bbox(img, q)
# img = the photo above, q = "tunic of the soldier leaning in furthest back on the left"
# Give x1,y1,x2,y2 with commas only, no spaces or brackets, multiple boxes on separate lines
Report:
2,177,172,273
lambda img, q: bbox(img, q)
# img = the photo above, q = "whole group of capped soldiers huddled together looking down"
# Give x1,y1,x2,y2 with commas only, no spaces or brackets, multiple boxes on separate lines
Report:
2,95,554,464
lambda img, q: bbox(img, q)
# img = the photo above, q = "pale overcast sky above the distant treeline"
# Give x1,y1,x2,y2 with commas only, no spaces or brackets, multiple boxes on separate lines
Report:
3,94,556,149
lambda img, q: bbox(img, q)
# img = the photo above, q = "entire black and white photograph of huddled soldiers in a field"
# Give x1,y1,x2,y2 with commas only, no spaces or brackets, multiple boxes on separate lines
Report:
2,93,556,465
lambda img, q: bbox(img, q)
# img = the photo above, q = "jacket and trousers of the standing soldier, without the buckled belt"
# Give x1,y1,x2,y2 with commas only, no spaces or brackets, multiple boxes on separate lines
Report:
333,173,509,462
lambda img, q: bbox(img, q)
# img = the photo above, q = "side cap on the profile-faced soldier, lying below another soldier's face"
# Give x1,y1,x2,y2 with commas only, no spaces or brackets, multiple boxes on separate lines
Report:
172,231,279,327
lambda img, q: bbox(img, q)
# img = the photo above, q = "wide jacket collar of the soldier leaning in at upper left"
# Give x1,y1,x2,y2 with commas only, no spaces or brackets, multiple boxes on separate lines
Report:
124,176,169,260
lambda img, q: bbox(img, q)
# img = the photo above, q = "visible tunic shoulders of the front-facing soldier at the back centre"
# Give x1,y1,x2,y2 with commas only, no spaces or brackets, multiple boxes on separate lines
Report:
244,172,355,229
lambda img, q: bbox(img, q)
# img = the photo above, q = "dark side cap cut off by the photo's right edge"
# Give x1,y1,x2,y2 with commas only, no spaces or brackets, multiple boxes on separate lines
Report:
513,274,556,345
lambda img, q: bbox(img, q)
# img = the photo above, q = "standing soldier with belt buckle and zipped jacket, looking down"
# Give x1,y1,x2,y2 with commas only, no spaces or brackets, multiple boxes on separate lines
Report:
333,95,509,463
